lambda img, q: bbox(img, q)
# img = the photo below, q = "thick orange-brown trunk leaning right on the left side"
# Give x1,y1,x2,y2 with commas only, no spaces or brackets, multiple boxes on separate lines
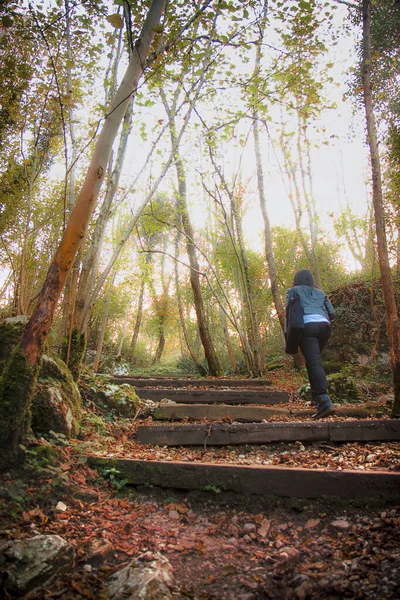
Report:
0,0,165,451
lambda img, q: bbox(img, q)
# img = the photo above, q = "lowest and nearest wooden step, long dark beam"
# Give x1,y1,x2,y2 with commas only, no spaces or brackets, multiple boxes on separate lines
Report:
87,456,400,501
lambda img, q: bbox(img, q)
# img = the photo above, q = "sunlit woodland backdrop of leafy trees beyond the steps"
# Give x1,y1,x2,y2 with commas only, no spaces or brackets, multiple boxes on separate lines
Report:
0,0,400,375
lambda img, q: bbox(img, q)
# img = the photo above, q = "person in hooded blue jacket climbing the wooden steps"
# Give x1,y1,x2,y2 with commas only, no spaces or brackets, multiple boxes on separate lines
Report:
286,269,335,419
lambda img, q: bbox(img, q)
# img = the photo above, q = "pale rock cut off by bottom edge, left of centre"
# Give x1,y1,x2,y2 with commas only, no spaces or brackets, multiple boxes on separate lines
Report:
106,553,173,600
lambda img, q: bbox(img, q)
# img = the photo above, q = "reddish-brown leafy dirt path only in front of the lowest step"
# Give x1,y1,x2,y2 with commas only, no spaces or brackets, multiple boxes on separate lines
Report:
0,458,400,600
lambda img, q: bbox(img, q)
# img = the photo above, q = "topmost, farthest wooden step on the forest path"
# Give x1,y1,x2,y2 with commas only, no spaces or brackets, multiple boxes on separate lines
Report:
112,375,272,388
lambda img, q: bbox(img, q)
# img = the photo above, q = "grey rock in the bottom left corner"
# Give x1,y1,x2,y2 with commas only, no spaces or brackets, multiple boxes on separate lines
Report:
0,535,75,598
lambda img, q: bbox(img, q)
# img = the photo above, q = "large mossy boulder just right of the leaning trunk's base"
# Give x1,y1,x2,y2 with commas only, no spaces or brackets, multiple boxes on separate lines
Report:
32,355,82,438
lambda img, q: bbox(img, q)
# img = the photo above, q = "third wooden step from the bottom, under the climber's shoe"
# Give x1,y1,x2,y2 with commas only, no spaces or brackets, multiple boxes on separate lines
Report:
153,404,384,423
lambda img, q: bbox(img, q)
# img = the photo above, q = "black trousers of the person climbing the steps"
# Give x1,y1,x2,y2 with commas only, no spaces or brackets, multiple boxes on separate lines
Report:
299,321,331,400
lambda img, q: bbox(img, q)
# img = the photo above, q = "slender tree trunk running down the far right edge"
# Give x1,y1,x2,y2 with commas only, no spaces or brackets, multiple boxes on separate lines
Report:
362,0,400,417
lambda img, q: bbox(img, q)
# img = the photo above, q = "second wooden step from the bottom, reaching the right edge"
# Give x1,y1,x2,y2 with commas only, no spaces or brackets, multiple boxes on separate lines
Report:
137,419,400,446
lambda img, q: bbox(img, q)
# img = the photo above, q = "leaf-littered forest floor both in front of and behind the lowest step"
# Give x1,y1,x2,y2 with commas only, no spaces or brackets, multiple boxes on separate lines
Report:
0,372,400,600
